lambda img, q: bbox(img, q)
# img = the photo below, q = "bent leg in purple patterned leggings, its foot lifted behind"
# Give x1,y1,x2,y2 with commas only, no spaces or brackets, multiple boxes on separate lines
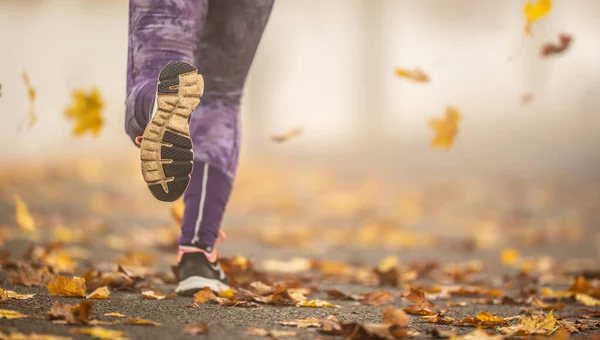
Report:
125,0,208,140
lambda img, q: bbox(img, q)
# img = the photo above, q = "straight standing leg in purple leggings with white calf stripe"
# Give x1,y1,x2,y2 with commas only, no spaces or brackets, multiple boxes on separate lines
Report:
180,0,273,253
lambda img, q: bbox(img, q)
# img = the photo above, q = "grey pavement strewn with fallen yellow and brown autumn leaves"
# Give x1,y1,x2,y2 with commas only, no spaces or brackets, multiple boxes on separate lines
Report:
0,158,600,339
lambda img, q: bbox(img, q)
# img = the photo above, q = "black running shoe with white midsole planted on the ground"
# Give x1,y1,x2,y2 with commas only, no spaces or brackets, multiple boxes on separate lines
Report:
175,250,231,296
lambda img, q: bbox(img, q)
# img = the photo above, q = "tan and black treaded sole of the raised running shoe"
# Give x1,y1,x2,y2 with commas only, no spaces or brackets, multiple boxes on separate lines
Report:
140,61,204,202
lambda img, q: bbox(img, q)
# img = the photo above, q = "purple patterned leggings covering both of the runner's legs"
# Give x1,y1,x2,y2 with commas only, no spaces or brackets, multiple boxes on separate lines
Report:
125,0,274,251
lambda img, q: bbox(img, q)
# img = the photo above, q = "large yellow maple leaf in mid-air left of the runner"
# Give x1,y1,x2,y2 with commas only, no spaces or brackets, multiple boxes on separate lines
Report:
65,89,104,136
